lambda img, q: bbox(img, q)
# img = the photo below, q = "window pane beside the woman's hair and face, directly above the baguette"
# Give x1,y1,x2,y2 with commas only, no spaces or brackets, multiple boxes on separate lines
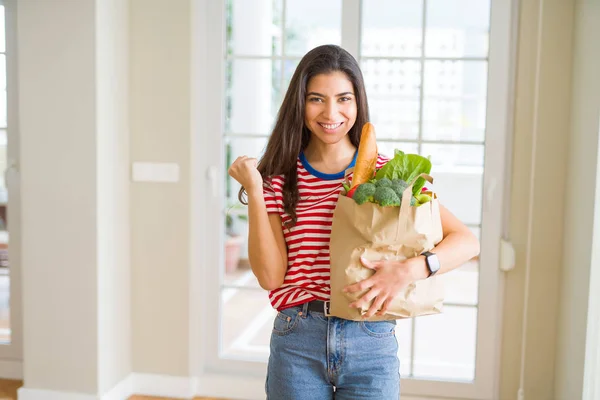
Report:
362,59,421,139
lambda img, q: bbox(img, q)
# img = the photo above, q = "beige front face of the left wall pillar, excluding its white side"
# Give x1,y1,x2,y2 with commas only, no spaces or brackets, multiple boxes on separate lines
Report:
17,0,98,393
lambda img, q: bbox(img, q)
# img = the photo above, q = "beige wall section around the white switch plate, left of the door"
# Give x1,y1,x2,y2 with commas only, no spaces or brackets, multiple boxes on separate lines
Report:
130,0,191,376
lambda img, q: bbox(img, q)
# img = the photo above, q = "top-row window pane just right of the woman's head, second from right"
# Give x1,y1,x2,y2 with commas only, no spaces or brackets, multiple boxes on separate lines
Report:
361,0,423,57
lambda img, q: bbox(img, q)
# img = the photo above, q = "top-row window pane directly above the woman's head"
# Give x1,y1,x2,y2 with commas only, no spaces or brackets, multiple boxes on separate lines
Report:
285,0,342,56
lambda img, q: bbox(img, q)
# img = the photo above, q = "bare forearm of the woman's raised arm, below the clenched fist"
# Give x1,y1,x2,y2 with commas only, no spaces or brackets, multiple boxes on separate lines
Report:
248,190,287,290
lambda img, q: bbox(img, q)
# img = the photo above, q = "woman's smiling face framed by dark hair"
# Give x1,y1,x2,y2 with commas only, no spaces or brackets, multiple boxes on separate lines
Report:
304,71,357,144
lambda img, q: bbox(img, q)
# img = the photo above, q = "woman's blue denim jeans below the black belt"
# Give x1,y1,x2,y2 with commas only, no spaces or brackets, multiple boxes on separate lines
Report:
265,304,400,400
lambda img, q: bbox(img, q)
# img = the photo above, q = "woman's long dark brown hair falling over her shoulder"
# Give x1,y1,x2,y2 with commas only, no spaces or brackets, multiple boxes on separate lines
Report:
238,45,369,224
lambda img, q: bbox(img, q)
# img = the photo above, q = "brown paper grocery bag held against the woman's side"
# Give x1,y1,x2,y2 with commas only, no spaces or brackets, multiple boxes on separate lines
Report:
329,174,444,321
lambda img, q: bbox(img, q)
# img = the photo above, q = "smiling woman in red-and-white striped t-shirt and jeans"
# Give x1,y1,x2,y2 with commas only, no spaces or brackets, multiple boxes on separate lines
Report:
229,45,479,400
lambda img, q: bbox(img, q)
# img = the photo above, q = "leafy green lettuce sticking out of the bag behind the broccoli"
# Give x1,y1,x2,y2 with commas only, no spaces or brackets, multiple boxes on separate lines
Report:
375,150,431,196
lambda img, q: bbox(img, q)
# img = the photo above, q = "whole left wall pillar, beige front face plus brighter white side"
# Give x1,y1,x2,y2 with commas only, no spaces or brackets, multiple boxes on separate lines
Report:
18,0,131,398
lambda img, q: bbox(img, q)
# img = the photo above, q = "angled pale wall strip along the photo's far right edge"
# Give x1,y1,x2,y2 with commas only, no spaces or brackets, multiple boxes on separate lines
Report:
555,0,600,400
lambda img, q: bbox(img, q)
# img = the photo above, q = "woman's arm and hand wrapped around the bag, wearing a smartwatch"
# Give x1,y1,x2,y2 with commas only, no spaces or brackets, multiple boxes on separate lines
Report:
344,205,479,318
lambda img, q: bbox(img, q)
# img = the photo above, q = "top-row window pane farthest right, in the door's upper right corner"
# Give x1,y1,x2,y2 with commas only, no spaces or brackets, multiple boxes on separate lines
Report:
425,0,490,57
